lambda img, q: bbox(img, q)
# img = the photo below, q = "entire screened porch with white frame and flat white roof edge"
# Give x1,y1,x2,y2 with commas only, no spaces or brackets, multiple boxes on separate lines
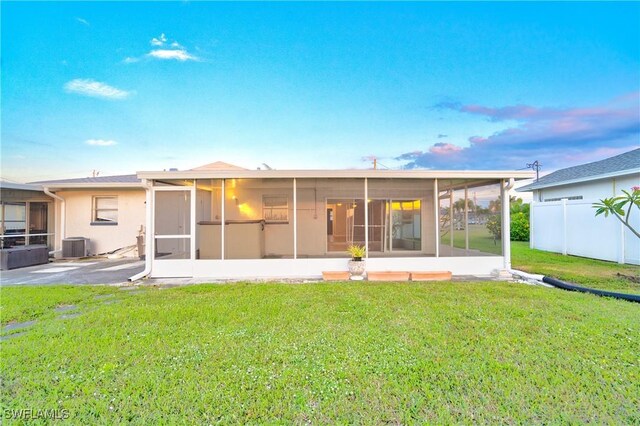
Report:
132,163,532,279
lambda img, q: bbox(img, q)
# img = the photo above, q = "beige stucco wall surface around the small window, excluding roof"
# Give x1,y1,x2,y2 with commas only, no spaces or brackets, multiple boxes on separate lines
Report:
55,188,146,254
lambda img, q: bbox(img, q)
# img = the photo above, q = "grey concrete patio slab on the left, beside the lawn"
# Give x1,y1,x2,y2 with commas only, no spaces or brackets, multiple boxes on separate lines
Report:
0,258,144,286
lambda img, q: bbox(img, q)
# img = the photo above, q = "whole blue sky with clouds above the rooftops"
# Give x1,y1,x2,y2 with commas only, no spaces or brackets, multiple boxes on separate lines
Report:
0,2,640,182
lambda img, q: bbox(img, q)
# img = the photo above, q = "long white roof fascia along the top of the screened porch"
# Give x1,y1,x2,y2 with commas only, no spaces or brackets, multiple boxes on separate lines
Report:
137,170,535,179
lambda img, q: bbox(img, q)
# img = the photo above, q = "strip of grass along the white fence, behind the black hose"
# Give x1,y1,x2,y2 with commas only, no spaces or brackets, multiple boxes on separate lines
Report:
511,241,640,294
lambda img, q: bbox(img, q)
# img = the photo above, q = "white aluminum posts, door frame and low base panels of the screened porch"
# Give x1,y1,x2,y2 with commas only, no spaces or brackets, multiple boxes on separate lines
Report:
147,177,508,279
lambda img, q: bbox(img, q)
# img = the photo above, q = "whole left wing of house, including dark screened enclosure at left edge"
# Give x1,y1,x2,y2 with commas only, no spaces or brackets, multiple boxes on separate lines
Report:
0,175,146,257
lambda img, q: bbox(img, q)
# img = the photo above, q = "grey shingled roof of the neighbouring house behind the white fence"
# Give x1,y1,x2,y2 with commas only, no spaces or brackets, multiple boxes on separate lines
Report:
517,148,640,192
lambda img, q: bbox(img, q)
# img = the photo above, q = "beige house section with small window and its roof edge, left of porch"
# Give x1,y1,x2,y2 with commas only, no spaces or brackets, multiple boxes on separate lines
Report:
34,175,146,256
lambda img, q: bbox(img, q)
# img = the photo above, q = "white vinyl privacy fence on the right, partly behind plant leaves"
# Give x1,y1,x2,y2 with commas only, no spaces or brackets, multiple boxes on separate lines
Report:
530,199,640,265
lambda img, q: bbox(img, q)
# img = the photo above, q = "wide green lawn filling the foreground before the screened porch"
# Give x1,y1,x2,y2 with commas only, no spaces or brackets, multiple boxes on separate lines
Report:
0,282,640,424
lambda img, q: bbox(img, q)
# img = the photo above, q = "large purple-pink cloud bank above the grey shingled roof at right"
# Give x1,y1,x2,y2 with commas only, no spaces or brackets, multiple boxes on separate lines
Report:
396,92,640,170
